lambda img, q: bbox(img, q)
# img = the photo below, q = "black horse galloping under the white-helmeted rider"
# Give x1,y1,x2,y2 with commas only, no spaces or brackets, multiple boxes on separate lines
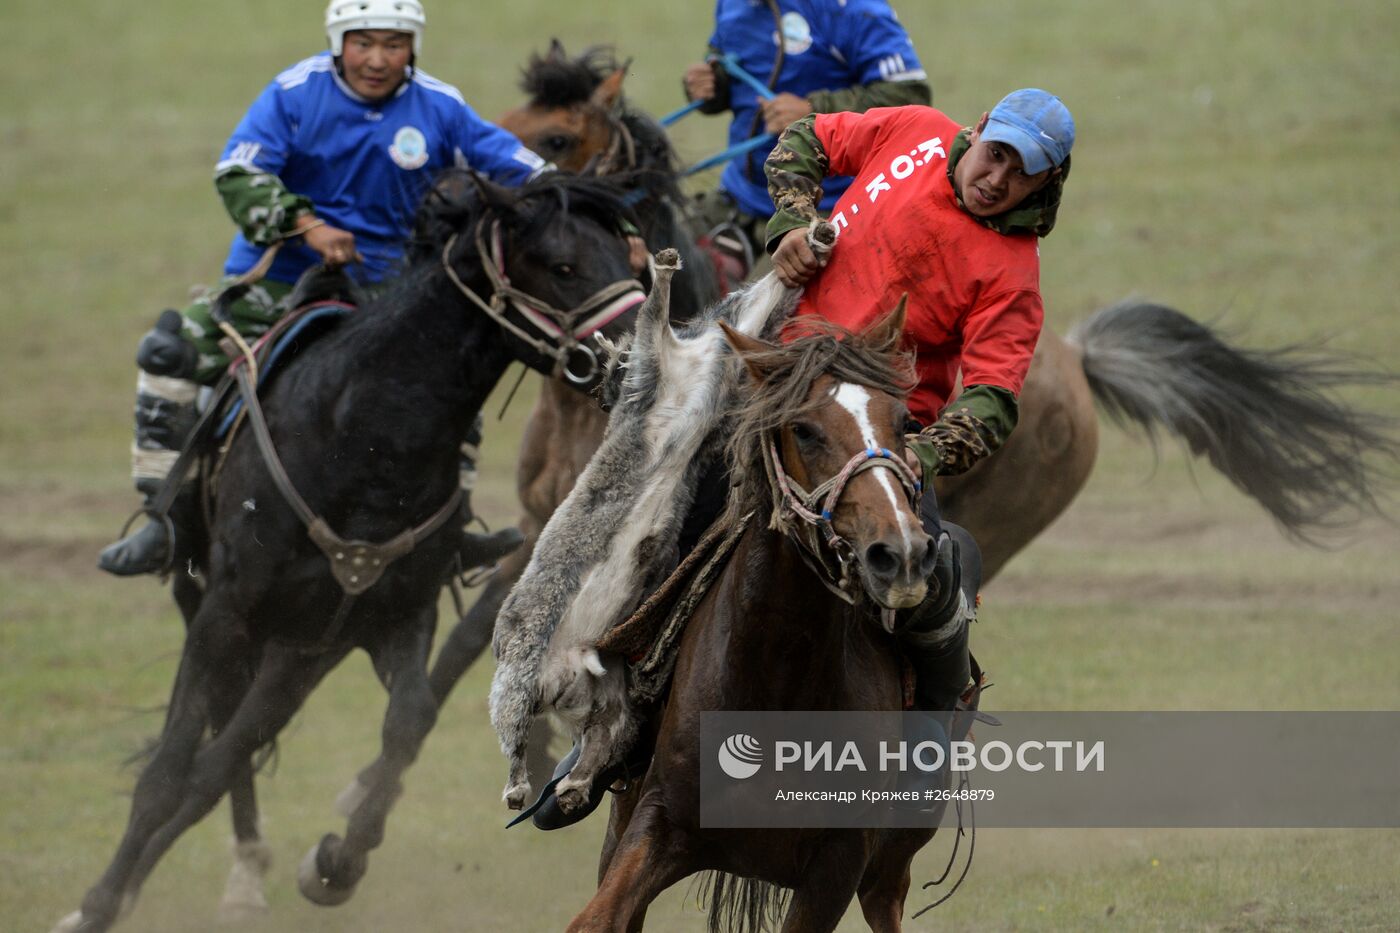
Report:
59,175,641,930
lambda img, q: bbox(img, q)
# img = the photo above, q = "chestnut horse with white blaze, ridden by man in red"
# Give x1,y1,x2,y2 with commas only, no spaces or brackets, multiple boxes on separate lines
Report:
570,311,934,932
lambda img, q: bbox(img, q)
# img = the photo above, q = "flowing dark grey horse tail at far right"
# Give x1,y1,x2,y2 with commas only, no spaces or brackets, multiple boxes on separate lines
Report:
1070,300,1400,541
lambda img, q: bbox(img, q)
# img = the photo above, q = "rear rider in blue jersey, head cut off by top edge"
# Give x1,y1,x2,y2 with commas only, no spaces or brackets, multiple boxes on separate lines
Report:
685,0,932,261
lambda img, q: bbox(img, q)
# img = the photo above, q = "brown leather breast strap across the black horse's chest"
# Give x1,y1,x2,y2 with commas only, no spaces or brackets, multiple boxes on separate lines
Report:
235,366,462,595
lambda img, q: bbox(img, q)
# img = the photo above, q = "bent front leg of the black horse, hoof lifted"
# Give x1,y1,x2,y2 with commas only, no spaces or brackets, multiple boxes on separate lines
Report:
297,607,437,906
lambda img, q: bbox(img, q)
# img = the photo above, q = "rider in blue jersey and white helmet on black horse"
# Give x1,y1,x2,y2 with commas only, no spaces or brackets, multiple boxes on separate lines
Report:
98,0,547,576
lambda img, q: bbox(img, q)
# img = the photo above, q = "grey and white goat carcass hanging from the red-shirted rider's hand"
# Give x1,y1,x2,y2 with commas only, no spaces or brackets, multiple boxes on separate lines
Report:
491,243,799,811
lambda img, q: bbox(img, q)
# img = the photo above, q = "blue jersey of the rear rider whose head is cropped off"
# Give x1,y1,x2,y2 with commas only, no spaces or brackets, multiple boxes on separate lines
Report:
710,0,925,217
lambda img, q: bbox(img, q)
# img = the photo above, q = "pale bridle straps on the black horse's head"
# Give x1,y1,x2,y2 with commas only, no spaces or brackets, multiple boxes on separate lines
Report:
442,217,647,385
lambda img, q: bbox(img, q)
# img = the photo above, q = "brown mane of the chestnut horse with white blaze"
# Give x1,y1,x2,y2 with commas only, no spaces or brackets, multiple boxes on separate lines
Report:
724,315,916,518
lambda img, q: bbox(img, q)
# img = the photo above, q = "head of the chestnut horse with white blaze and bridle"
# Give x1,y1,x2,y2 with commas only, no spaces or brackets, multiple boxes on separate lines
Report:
725,301,935,621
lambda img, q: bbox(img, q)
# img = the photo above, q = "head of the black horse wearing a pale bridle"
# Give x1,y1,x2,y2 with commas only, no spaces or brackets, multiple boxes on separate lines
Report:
410,171,645,388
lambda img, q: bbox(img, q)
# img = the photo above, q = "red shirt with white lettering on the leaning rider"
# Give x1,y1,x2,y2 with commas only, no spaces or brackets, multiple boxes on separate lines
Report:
798,106,1044,423
